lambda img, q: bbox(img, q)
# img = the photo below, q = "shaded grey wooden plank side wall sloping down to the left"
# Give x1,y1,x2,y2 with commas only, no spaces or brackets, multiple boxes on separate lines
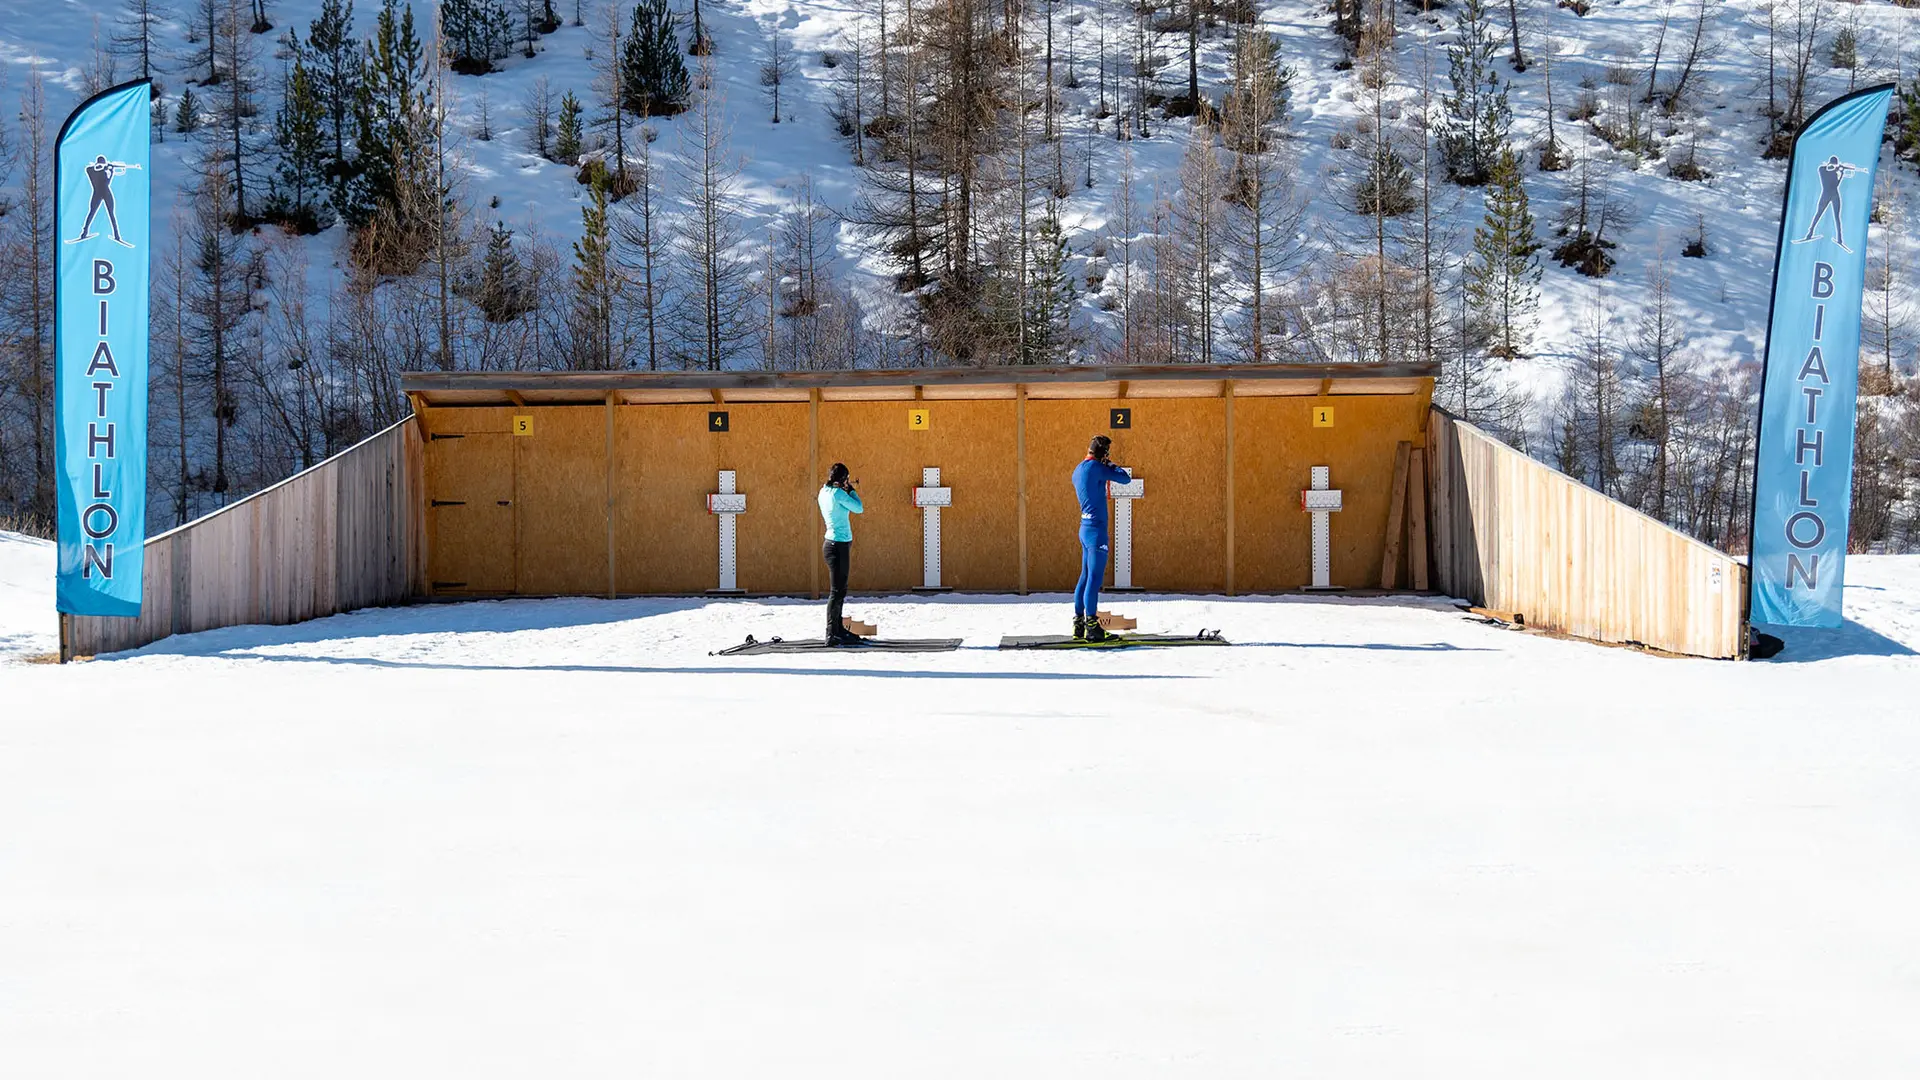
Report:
61,417,426,659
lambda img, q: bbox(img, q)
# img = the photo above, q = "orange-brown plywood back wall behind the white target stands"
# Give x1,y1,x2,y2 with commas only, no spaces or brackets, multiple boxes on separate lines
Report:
422,384,1428,596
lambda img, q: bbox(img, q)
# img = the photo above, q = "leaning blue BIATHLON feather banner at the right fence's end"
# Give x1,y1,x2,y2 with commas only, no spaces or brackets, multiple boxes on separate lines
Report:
1749,86,1893,626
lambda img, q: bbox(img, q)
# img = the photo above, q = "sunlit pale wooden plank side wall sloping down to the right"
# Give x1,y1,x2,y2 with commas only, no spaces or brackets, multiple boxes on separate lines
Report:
1427,409,1745,657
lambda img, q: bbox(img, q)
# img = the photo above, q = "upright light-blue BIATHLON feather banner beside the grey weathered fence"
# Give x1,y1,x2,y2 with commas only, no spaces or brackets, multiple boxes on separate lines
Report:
54,79,154,615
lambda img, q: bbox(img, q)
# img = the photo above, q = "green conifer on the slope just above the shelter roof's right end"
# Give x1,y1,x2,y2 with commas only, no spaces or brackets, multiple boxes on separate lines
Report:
1467,146,1540,359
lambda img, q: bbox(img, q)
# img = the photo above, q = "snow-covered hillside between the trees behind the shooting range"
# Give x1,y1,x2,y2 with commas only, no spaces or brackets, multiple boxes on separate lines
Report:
0,0,1920,542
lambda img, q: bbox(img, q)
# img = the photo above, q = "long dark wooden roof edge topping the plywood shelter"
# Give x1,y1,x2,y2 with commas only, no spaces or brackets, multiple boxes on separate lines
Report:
399,363,1440,392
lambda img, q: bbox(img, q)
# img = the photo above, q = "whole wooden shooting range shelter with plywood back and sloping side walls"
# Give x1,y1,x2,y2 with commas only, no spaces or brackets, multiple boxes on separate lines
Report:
65,363,1743,655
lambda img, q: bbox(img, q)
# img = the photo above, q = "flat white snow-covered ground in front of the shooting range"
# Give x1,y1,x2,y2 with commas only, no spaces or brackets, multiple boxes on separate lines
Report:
0,536,1920,1080
